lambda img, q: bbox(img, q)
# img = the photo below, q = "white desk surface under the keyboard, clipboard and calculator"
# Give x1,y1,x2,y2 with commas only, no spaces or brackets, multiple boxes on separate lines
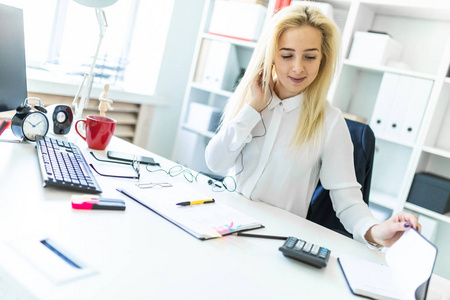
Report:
0,134,450,299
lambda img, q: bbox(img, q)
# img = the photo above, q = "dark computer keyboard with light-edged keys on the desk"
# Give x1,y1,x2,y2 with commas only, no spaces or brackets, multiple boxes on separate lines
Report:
36,137,102,194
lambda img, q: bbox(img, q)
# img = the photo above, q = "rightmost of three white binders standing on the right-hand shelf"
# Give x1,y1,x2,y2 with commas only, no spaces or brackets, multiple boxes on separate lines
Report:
400,78,433,143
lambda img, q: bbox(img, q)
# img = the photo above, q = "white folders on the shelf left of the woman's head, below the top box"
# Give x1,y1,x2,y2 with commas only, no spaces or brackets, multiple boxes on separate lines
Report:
202,40,240,91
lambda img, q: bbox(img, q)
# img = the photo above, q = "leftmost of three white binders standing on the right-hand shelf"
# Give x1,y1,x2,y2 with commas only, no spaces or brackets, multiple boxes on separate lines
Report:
370,73,400,137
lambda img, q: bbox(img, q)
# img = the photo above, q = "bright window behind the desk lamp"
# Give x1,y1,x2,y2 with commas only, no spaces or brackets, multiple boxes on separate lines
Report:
0,0,174,94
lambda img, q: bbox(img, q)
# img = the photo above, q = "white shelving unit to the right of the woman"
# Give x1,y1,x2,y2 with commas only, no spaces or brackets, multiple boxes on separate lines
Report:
329,0,450,278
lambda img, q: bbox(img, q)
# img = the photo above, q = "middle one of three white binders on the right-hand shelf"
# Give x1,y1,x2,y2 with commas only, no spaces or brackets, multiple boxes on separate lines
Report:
383,75,416,140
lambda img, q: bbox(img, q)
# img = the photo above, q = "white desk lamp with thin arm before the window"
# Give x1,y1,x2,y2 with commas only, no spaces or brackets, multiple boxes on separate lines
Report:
72,0,118,120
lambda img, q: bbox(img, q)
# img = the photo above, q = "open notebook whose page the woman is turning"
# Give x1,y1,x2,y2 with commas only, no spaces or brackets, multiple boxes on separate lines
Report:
338,229,437,299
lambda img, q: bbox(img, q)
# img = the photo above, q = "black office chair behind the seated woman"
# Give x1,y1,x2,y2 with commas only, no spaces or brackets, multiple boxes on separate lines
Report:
306,119,375,238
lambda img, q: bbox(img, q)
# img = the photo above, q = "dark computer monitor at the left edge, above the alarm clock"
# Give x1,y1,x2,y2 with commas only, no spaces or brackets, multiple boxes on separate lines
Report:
0,4,27,112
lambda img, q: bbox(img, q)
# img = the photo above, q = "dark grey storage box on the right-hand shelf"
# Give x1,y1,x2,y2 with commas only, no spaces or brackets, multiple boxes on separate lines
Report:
408,173,450,214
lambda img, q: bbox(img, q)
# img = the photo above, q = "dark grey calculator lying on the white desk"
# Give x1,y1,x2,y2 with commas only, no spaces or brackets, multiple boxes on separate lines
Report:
279,236,331,268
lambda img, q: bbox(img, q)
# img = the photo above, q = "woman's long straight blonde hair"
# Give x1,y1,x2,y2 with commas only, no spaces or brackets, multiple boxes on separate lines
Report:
222,5,339,149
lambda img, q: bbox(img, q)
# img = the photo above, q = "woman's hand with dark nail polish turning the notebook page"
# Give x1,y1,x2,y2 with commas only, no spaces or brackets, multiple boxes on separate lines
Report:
364,212,421,247
